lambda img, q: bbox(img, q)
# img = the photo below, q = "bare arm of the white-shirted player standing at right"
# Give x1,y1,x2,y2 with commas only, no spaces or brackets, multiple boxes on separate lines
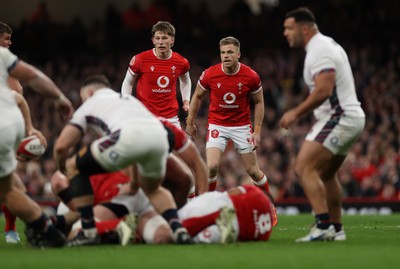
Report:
279,69,335,129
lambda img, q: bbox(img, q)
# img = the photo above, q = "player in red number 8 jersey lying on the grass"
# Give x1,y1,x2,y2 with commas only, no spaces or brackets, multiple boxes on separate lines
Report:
178,185,274,243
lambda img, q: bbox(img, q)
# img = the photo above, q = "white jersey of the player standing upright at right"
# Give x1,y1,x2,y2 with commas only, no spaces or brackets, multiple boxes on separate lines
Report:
303,33,365,119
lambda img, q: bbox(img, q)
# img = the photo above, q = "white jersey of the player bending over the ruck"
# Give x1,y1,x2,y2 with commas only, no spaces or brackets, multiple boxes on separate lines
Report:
70,88,162,137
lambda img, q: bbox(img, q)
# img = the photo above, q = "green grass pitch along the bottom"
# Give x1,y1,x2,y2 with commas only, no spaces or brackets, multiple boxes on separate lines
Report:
0,214,400,269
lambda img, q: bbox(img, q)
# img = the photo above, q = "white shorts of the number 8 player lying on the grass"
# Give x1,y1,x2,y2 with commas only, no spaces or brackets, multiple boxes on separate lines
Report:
178,191,239,243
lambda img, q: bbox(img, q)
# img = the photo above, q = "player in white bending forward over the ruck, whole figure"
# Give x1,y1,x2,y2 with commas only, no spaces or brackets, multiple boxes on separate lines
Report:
54,75,191,246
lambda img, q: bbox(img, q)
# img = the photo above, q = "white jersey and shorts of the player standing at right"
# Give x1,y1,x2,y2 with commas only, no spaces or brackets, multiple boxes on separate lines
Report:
303,33,365,155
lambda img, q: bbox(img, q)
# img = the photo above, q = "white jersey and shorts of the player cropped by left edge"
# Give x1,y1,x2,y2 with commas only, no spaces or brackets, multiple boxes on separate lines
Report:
0,47,25,177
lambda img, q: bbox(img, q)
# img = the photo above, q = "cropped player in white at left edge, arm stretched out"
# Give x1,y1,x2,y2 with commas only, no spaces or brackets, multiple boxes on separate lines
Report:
0,44,73,247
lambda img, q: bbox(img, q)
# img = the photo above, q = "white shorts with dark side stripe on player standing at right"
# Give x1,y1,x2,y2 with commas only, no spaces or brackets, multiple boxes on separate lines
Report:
306,115,365,155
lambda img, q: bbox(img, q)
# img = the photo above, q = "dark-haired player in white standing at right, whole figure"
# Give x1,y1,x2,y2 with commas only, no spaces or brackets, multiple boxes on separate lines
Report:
279,7,365,242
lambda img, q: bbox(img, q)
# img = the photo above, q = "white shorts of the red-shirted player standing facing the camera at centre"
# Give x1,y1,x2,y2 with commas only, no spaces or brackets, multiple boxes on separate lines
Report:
206,124,254,154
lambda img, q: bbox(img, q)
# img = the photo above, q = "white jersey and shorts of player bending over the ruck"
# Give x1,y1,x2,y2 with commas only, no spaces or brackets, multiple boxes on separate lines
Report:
70,88,169,178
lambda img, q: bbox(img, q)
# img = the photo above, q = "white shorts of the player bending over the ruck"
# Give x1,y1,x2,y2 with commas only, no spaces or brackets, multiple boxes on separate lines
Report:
91,123,169,179
